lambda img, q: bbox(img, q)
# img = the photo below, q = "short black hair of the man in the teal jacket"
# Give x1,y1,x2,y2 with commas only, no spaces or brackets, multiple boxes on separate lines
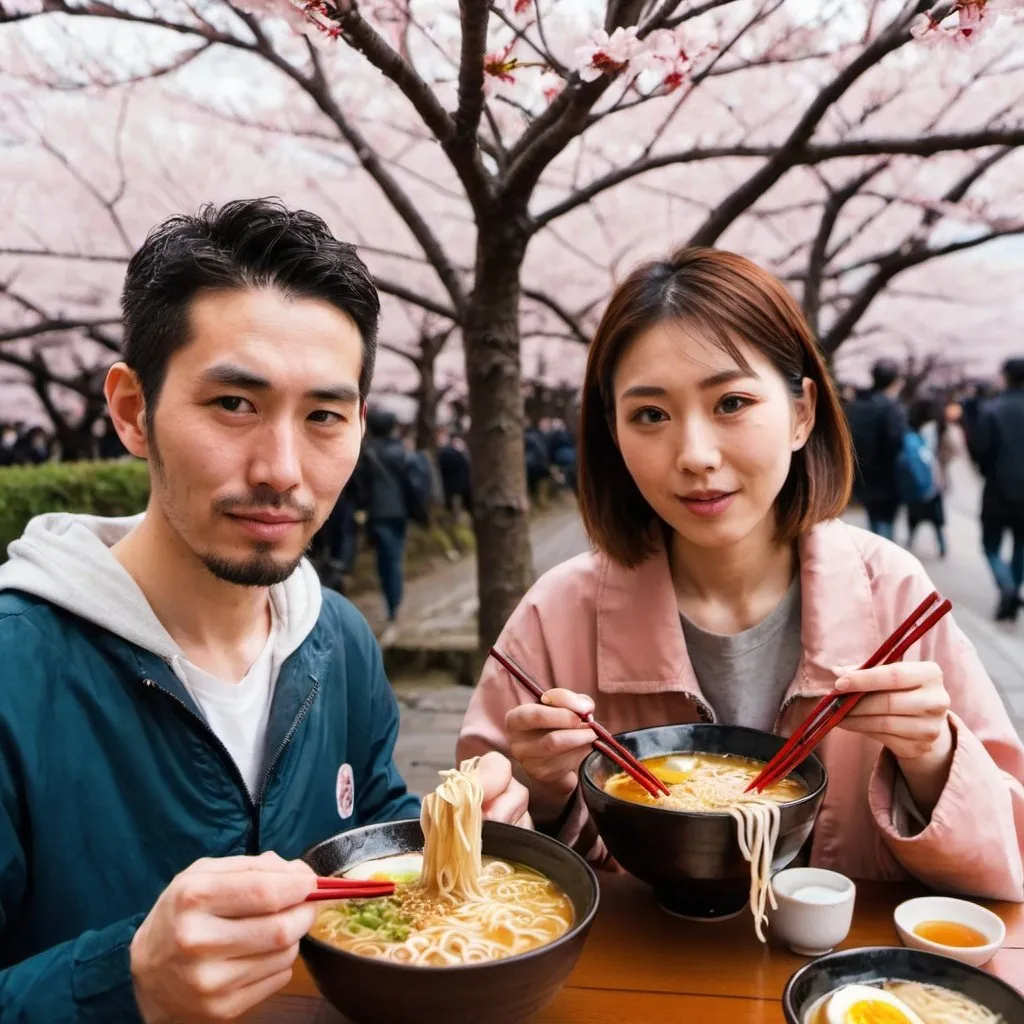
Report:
121,199,381,422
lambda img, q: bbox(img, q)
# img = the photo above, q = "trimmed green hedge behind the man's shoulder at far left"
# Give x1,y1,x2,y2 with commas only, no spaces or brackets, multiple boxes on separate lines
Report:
0,460,150,561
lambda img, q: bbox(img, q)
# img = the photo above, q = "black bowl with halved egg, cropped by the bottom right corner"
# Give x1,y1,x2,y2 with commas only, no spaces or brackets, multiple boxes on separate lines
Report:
782,946,1024,1024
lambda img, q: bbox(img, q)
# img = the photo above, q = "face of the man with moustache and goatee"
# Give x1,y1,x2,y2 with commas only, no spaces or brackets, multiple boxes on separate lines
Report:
150,288,362,587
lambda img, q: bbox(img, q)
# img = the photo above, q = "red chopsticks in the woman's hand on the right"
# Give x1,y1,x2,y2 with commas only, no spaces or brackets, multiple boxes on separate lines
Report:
746,591,952,793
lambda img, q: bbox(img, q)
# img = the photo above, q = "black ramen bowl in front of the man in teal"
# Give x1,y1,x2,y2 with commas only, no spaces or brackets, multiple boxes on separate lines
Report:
301,820,598,1024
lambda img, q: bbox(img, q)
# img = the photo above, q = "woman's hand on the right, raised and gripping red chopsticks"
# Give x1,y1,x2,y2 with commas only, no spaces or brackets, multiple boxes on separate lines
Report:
836,662,955,814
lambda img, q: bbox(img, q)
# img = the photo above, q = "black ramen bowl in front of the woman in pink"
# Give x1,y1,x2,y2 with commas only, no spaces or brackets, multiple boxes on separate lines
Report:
580,725,828,920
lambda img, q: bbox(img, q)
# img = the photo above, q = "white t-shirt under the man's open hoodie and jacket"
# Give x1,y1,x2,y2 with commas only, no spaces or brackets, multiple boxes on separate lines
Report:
177,616,278,800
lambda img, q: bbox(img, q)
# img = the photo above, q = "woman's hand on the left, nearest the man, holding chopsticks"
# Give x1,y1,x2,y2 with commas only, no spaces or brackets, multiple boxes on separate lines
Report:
505,688,597,820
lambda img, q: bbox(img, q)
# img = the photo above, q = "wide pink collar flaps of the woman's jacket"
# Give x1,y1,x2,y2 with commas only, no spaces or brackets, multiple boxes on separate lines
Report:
597,520,883,702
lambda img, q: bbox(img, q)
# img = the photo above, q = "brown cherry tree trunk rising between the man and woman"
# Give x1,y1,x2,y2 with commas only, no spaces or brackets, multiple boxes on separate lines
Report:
463,228,534,651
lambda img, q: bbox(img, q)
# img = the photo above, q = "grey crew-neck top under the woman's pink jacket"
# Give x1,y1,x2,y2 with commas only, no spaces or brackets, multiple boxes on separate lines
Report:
679,577,803,732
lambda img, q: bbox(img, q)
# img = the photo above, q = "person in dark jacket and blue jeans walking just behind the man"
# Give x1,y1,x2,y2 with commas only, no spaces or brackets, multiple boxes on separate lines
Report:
354,409,432,646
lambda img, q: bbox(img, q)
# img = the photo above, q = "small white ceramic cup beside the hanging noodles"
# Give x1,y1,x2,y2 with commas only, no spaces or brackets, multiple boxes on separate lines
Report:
768,867,857,956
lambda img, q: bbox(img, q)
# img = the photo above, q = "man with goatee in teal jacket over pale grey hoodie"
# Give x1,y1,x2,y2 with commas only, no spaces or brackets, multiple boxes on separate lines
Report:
0,195,526,1024
